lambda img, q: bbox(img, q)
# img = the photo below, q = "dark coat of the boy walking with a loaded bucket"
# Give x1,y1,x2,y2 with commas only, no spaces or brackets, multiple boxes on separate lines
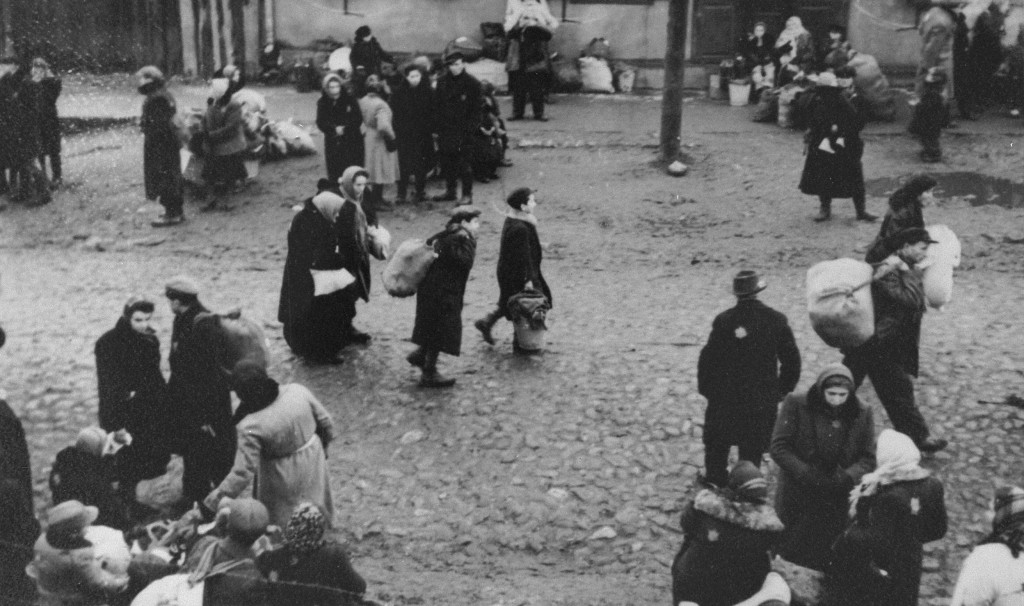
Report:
498,215,555,319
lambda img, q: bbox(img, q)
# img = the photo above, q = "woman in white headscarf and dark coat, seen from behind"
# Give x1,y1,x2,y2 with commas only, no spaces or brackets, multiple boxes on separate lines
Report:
825,429,946,606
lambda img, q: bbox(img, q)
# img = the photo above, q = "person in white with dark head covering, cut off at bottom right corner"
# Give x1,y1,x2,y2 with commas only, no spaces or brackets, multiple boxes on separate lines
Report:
949,486,1024,606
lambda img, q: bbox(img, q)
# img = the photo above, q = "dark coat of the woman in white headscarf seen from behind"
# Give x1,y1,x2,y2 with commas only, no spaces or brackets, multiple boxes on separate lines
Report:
827,476,946,606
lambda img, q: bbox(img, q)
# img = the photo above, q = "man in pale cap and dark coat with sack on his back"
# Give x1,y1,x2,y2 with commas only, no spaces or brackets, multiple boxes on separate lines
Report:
165,275,236,504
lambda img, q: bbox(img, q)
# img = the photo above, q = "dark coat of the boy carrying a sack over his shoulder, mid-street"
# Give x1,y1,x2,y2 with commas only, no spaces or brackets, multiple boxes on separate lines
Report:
413,225,476,355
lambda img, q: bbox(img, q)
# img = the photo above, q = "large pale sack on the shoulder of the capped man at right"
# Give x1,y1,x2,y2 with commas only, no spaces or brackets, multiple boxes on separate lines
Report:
807,259,874,349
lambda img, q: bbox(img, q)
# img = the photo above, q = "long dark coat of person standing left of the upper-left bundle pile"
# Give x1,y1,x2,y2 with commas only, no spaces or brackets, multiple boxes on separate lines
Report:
141,83,182,200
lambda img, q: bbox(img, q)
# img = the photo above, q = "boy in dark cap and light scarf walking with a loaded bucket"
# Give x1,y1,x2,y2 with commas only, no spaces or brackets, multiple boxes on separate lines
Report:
473,187,554,349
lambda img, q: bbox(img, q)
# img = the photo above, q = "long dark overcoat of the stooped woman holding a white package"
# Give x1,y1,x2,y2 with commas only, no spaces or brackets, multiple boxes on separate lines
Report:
278,199,345,357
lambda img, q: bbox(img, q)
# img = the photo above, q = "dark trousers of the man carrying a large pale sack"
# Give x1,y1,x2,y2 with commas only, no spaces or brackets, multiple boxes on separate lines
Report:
843,347,929,444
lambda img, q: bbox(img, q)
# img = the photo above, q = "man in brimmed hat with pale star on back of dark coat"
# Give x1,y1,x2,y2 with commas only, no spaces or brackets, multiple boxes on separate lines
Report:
697,270,800,486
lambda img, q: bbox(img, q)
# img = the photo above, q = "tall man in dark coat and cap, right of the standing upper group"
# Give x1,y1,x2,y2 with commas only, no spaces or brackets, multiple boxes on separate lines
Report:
435,51,481,206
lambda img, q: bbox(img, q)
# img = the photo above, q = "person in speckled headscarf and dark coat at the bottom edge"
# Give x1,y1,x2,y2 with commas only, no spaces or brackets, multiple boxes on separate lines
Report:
256,503,367,606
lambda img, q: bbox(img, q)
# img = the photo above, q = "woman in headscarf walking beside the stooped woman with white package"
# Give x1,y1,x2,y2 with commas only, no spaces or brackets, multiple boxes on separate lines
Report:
336,166,377,344
